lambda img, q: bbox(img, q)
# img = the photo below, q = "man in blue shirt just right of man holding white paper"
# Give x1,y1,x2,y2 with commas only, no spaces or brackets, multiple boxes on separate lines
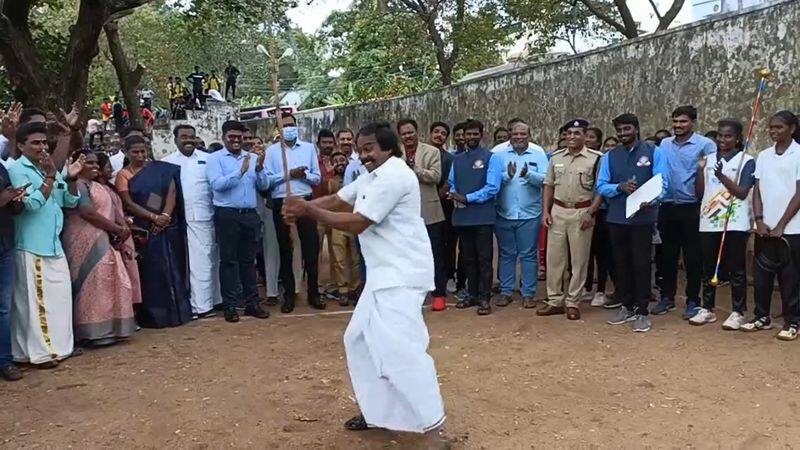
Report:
653,106,717,320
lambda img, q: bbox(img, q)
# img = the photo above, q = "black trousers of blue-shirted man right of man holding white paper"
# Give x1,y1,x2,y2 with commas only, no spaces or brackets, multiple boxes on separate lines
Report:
658,203,703,303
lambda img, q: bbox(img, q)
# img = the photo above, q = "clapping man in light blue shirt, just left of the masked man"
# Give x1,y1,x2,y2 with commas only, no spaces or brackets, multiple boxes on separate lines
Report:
206,120,269,322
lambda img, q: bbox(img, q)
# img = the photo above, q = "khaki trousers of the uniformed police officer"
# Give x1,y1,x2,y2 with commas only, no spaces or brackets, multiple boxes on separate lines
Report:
547,205,594,308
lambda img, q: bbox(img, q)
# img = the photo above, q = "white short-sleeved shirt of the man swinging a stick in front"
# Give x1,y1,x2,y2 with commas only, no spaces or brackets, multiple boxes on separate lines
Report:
337,157,434,290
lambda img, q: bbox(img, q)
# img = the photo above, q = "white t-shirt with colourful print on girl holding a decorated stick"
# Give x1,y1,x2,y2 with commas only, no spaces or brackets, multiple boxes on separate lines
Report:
700,151,753,232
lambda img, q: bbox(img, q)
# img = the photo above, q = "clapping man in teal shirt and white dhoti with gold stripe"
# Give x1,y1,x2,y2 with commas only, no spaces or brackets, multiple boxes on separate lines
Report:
8,123,84,369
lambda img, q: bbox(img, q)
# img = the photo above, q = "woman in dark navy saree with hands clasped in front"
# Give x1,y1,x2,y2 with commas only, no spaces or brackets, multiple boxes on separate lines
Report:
115,136,192,328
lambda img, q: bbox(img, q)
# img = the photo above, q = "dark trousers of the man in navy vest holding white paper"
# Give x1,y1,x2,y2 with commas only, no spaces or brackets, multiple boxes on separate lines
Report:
608,223,653,315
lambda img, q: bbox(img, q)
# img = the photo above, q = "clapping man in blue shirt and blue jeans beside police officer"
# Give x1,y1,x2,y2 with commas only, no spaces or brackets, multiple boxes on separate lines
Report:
492,122,547,308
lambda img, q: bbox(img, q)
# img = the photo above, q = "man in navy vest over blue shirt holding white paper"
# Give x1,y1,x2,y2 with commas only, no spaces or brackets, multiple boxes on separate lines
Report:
596,113,669,332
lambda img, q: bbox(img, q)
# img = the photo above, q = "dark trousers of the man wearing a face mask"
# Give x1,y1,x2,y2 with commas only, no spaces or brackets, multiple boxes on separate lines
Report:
272,196,319,301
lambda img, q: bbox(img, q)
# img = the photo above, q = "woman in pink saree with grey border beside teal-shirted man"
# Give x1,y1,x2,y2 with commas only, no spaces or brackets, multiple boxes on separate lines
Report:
63,150,138,347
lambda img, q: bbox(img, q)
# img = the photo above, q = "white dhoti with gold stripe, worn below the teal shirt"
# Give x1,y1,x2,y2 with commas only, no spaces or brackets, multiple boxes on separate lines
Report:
11,250,73,364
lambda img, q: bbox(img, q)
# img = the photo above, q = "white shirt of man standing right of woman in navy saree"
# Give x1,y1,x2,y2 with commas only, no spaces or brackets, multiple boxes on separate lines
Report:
162,150,214,222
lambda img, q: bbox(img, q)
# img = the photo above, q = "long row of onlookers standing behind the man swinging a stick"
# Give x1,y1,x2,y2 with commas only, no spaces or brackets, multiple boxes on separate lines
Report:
0,100,800,380
